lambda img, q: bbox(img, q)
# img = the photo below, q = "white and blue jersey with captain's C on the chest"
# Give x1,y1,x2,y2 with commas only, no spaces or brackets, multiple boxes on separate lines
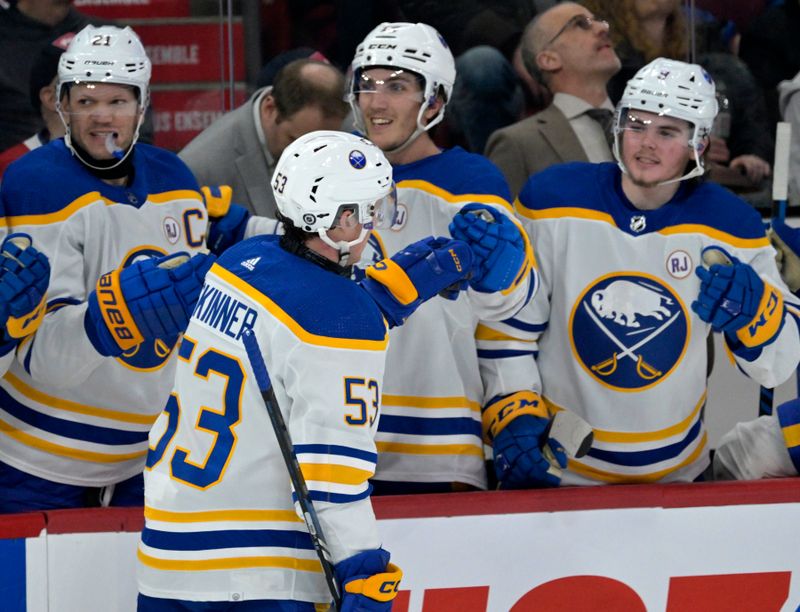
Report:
0,140,207,486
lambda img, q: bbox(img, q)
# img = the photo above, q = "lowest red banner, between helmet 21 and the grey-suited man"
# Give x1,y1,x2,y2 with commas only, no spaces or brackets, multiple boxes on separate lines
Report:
150,89,247,151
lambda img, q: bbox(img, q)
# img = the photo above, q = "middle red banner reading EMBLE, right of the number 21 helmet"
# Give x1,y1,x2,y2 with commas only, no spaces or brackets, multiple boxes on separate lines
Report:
134,20,245,83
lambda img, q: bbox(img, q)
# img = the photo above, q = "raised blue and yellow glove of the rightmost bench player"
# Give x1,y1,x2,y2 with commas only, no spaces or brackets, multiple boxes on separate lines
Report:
692,247,784,349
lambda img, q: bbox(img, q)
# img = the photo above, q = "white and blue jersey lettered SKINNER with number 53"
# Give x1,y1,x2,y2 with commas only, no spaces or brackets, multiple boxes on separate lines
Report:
138,236,388,603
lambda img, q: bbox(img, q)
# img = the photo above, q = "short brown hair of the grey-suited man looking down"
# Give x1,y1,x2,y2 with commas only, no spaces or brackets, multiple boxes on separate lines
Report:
270,59,348,120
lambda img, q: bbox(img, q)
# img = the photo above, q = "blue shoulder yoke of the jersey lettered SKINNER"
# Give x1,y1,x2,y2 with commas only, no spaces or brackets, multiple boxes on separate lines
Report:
217,236,386,340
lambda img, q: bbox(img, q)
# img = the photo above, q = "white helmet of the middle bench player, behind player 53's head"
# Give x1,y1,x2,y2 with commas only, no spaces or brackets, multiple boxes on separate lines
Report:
347,22,456,147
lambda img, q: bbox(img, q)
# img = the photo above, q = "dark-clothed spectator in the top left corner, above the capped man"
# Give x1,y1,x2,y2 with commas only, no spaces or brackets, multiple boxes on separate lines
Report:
0,0,100,151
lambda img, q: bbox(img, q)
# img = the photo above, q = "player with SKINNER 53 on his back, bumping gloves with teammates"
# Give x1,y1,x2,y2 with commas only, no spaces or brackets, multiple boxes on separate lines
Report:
138,132,472,612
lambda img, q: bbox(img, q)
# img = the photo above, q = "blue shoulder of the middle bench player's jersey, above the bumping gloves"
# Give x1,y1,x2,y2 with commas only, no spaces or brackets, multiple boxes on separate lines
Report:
394,147,511,202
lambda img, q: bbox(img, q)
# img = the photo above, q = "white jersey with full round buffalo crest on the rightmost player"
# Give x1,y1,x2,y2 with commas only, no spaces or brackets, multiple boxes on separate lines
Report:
517,163,800,484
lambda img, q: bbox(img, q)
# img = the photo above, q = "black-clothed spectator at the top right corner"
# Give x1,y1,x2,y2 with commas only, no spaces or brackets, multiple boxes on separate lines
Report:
739,0,800,125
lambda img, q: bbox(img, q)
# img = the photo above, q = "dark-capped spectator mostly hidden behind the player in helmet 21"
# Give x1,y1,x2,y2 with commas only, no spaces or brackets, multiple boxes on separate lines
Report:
0,32,75,179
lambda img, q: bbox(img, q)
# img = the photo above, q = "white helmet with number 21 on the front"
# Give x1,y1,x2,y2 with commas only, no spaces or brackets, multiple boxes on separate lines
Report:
56,25,151,169
